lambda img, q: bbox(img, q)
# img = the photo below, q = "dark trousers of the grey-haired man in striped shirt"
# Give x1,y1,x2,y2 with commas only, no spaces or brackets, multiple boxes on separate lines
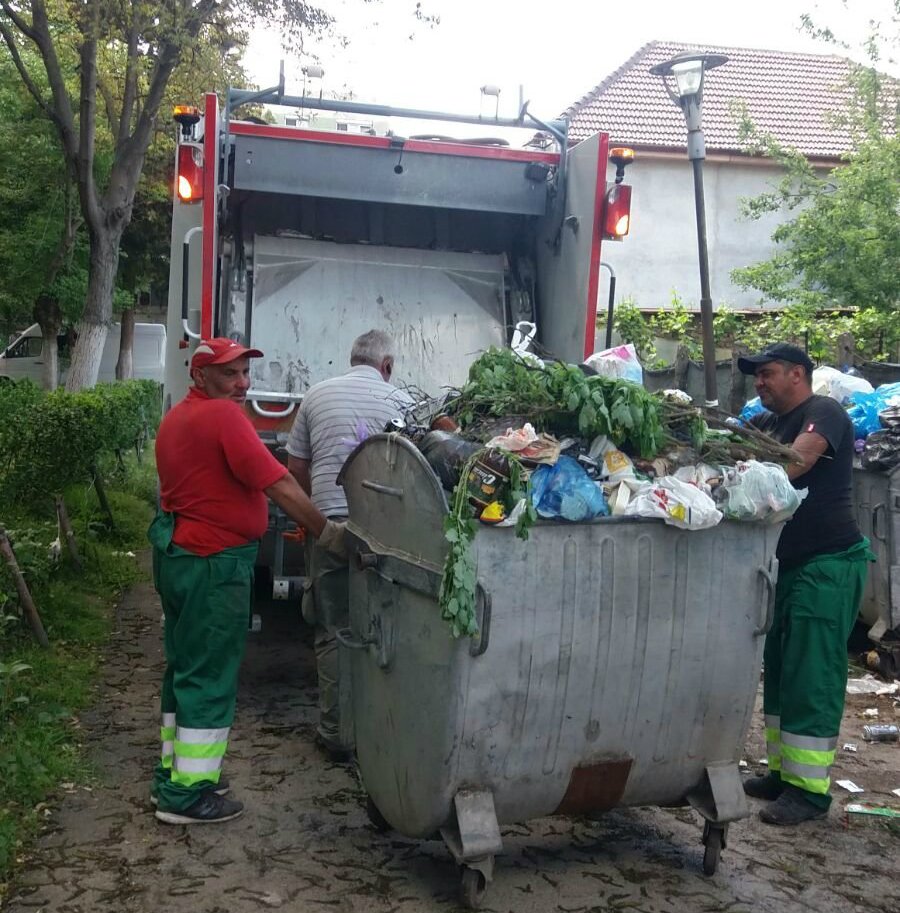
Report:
303,538,354,751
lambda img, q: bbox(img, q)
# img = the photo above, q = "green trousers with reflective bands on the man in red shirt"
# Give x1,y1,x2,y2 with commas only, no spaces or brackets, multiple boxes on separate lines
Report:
149,514,258,811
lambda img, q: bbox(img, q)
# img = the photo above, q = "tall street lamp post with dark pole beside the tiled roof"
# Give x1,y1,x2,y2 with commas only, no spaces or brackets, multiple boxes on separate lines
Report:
650,52,728,409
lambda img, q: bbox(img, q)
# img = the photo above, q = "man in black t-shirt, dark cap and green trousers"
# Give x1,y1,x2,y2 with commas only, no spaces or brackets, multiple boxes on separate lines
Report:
738,343,874,824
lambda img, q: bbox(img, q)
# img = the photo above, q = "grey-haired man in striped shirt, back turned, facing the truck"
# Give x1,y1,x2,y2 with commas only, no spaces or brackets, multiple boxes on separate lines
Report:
287,330,412,761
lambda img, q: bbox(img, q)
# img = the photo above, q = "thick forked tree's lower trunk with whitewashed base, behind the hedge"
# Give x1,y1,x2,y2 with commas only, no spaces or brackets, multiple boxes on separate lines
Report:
66,224,124,391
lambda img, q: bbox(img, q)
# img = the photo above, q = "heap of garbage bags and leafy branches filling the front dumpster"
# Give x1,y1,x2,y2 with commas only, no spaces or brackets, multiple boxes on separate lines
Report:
410,349,804,534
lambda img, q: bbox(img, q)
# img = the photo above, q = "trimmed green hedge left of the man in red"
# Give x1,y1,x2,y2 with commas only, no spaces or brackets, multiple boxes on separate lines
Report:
0,380,159,502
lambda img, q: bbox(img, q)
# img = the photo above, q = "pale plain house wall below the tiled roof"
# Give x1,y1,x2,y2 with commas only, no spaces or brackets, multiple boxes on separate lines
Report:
599,153,785,310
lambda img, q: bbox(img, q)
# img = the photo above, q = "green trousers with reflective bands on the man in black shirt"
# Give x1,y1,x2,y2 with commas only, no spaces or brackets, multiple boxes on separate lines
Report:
763,539,874,808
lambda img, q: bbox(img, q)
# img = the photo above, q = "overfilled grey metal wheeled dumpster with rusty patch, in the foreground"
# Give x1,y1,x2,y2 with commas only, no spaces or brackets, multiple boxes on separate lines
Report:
339,435,780,906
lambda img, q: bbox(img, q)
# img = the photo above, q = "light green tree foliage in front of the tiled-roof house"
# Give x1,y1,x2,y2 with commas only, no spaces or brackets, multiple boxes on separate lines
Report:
732,30,900,318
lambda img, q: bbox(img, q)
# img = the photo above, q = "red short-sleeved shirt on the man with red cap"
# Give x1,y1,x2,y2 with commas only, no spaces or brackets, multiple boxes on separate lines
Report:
156,387,287,555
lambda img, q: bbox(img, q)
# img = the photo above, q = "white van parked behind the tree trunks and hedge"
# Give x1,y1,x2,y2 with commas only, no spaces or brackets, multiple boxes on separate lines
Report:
0,323,166,384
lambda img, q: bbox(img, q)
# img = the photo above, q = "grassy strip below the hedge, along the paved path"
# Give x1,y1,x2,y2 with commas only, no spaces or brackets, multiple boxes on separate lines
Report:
0,457,156,902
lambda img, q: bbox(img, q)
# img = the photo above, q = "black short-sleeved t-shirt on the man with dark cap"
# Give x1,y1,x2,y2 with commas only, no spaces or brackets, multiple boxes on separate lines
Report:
751,395,862,567
